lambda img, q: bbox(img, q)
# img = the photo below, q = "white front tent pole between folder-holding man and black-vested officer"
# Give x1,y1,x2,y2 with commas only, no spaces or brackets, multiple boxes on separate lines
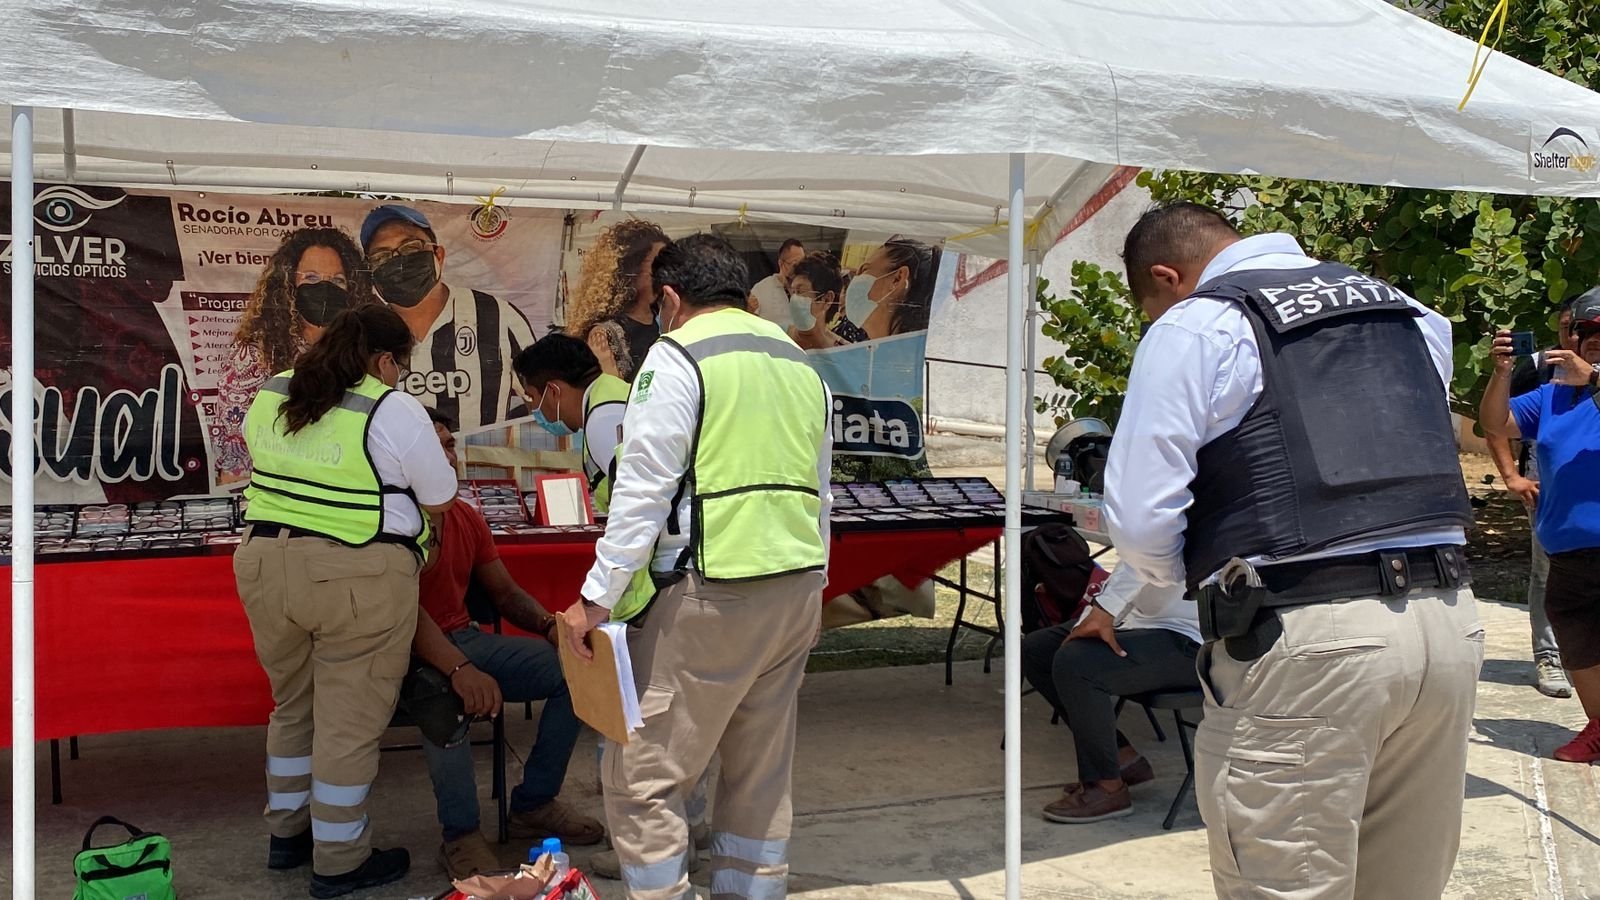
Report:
1003,154,1027,900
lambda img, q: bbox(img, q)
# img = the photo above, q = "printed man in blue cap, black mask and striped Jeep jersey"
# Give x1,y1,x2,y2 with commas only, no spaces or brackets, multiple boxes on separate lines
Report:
362,203,533,432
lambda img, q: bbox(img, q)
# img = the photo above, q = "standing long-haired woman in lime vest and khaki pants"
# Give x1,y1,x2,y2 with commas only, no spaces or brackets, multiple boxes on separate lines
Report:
234,304,456,897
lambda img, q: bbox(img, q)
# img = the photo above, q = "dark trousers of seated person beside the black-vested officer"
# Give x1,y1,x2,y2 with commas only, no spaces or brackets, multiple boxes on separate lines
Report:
1022,625,1200,783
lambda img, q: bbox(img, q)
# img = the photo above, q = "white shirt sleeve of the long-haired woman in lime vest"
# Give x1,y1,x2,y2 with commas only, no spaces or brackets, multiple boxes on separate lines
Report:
366,391,456,538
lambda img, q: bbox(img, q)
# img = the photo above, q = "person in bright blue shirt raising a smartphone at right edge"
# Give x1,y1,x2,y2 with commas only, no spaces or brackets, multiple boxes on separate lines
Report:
1480,288,1600,762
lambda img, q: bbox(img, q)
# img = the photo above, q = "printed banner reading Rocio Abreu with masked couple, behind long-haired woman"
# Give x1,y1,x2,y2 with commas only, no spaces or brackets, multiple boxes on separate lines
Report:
0,184,563,503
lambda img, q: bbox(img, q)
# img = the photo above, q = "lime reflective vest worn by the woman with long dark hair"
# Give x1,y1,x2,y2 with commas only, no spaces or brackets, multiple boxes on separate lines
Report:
245,372,429,552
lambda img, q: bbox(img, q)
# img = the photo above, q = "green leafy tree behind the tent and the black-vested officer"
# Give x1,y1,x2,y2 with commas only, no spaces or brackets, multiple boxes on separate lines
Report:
1045,0,1600,412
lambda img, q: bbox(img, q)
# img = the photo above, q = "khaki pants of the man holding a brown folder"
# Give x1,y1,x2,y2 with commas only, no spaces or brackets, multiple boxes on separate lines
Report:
600,573,822,900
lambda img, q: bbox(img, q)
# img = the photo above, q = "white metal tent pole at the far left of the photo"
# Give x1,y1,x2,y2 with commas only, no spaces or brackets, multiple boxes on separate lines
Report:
11,106,35,900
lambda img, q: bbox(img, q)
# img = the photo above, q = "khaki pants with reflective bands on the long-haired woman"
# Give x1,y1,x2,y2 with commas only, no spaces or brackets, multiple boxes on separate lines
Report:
234,536,418,876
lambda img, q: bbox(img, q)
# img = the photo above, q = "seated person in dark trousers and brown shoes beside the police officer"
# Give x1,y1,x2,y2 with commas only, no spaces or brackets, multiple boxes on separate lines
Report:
1022,567,1200,825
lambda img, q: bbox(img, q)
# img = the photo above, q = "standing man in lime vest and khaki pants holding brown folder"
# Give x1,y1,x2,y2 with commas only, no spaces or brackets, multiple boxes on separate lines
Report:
562,235,832,900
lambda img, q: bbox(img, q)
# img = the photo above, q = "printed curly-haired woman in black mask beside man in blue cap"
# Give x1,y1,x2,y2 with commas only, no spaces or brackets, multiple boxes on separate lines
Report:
214,227,376,487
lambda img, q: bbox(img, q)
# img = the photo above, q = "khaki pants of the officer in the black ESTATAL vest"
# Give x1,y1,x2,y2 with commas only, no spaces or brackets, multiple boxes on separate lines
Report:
1195,588,1483,900
